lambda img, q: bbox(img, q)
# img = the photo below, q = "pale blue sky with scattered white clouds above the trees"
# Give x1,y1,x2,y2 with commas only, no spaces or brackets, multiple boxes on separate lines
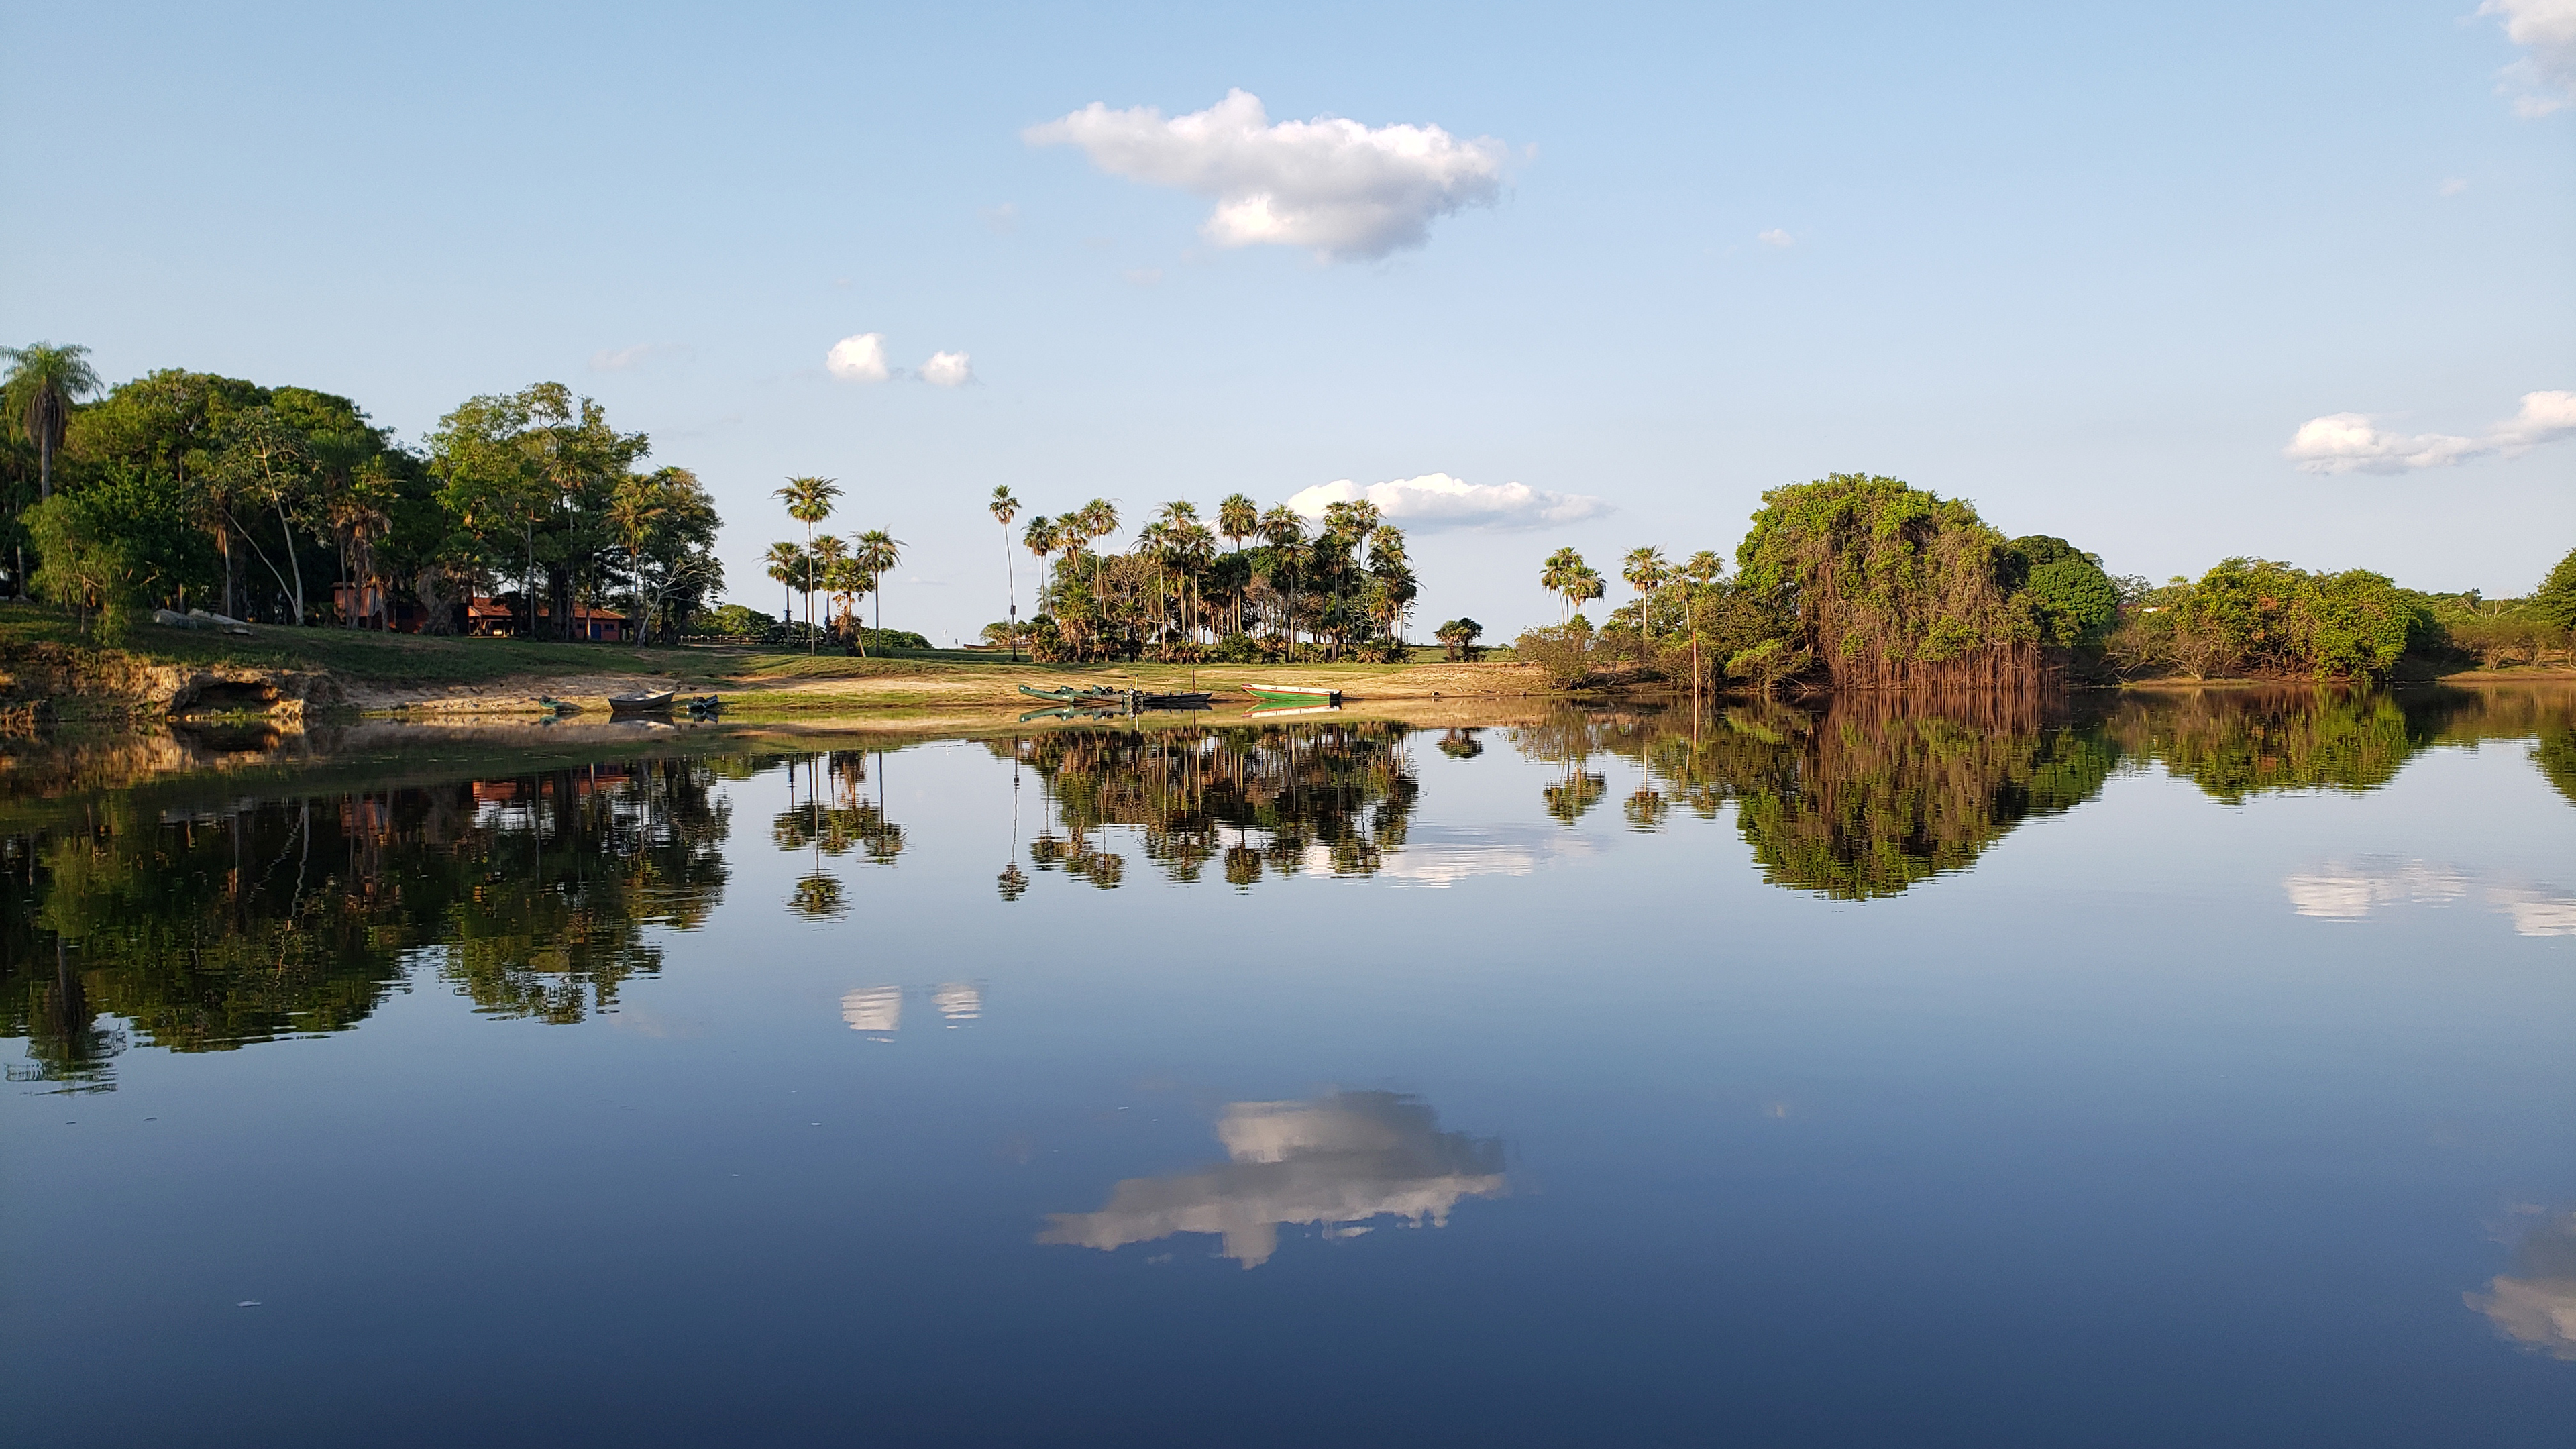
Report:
0,0,2576,642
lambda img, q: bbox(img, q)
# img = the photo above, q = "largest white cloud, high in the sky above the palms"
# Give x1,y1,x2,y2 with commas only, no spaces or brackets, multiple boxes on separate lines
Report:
1022,91,1507,260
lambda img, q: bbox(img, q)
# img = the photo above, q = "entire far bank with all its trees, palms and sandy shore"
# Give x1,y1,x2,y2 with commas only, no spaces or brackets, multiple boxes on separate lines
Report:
0,343,2576,733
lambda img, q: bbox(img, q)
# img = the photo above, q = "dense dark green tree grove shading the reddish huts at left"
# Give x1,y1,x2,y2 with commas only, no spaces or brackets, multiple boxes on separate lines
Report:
0,343,724,639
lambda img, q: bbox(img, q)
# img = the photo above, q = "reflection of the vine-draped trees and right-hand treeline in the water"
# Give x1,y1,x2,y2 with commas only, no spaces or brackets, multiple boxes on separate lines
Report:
1512,688,2576,900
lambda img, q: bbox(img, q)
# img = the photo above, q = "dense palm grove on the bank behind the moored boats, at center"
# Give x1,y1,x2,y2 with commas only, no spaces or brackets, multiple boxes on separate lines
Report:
984,490,1422,663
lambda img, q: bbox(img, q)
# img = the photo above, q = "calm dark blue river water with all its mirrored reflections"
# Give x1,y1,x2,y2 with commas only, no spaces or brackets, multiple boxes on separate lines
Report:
0,688,2576,1446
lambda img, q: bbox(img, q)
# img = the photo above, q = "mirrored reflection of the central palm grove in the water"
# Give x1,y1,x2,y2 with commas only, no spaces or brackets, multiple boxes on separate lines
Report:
991,722,1422,890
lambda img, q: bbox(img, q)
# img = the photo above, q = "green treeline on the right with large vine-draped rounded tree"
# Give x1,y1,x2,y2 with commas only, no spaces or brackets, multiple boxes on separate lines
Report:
1517,474,2576,691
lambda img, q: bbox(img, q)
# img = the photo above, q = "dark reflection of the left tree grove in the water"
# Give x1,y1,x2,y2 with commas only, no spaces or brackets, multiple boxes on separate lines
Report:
0,761,727,1080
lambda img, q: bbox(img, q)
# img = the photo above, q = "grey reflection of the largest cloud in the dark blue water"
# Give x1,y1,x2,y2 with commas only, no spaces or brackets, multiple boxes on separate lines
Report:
1038,1091,1505,1269
